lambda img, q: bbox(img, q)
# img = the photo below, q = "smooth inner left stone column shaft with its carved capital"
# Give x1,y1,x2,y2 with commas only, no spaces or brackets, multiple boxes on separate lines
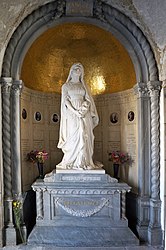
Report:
11,81,22,195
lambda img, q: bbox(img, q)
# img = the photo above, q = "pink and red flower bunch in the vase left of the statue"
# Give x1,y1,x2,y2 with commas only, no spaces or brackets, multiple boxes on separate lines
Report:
27,150,48,163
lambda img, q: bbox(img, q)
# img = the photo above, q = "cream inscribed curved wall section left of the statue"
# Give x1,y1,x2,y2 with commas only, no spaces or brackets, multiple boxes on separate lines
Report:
21,88,62,191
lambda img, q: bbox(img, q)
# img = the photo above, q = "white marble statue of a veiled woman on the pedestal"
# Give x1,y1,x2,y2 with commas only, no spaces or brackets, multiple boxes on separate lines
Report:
56,63,101,170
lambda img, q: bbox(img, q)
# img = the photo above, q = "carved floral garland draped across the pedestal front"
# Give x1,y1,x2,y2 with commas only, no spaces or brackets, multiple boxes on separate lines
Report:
55,198,109,217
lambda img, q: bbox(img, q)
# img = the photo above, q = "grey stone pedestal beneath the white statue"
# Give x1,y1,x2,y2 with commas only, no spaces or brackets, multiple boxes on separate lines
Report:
28,170,139,247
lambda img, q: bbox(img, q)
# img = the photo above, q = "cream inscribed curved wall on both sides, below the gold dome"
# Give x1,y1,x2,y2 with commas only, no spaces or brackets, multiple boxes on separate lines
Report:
21,88,138,191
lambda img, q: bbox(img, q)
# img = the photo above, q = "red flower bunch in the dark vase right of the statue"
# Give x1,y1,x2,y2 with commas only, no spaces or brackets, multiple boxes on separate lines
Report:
108,151,131,164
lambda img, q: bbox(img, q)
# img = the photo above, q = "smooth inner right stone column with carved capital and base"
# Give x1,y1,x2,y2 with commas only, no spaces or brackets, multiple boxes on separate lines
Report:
134,82,150,242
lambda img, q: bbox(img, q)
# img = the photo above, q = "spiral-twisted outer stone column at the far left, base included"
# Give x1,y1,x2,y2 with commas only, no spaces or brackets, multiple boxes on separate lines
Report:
1,78,16,245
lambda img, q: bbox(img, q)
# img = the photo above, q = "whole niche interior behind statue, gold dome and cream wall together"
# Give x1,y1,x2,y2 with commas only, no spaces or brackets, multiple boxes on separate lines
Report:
21,22,138,191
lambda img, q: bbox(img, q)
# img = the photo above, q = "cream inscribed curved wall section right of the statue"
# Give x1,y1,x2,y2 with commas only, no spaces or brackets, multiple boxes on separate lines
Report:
96,89,138,192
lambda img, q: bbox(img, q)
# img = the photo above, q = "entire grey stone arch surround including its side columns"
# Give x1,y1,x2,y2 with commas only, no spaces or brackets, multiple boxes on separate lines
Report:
1,0,162,245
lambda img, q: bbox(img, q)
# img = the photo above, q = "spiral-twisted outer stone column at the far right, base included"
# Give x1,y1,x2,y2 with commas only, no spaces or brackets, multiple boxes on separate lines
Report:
147,81,162,245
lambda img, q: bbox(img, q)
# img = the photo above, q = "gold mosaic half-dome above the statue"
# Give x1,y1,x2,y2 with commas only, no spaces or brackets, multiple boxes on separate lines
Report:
21,23,136,95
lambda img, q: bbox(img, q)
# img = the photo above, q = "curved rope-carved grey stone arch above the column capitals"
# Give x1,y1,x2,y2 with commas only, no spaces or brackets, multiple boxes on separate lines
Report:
2,0,158,82
